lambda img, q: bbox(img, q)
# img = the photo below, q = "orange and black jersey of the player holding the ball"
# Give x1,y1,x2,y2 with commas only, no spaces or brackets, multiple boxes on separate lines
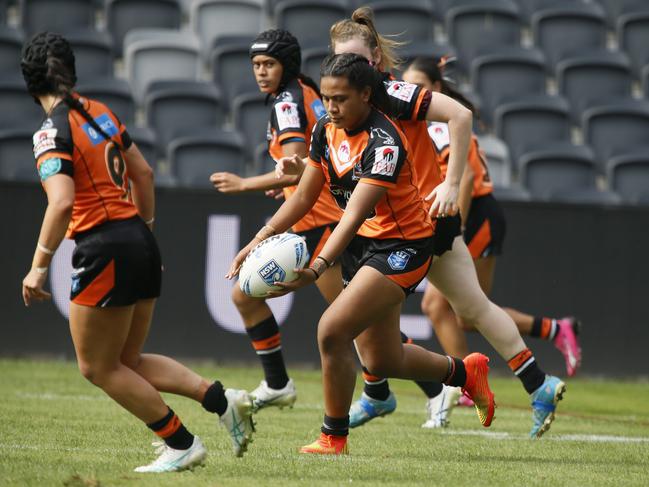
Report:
309,109,434,240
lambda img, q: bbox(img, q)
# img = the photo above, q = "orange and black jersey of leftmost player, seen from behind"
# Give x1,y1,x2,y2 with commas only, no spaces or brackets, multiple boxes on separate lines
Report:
34,95,137,238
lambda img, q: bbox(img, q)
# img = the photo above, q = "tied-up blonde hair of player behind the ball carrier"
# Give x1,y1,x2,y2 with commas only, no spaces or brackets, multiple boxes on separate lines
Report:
329,7,405,71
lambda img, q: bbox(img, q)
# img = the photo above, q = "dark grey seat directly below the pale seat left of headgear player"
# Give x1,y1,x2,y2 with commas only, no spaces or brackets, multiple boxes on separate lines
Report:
145,81,226,155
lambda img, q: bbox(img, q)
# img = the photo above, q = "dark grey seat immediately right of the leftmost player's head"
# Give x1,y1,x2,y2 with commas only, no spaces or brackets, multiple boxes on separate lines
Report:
66,30,113,83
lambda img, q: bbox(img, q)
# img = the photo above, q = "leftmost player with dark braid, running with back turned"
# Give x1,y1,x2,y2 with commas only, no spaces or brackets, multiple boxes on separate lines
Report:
21,32,253,472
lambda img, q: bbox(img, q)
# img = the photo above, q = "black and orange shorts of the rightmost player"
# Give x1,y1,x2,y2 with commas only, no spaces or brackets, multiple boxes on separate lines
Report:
464,194,506,259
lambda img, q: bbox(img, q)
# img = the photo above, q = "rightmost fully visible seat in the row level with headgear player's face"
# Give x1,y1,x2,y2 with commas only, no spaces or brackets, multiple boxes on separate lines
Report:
557,51,633,121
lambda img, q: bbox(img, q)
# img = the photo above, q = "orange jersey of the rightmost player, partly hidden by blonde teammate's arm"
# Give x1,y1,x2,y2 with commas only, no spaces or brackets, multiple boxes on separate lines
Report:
428,122,493,198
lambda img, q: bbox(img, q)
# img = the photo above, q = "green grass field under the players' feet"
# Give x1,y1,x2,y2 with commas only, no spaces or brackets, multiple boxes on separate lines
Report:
0,360,649,487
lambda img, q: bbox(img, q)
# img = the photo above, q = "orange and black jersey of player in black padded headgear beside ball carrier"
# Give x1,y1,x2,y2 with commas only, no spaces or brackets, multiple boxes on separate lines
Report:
268,79,340,232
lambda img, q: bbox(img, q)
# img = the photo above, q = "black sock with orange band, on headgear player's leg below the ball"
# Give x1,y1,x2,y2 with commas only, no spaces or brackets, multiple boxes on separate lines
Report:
247,315,288,389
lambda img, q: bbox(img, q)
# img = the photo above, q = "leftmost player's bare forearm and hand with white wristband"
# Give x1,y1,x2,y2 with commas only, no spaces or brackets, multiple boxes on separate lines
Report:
22,173,74,306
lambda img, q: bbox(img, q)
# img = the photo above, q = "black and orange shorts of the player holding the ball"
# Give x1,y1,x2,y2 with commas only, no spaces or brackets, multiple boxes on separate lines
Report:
340,235,433,296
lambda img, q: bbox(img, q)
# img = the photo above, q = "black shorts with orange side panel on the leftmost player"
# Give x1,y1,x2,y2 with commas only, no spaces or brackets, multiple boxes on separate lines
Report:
70,216,162,307
